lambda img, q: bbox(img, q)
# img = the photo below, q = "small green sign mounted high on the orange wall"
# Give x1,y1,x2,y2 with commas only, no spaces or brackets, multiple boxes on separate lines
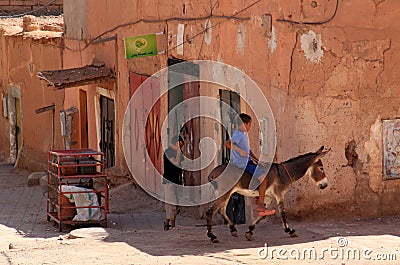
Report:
125,34,158,59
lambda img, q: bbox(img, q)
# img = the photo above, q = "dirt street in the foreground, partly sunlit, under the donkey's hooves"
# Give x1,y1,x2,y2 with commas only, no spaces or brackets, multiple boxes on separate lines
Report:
0,169,400,265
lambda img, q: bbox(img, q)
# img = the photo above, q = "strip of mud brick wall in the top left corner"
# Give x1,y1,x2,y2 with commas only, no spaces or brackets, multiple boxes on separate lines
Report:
0,0,63,15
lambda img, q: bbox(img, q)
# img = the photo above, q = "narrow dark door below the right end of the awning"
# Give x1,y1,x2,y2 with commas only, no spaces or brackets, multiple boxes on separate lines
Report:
100,96,115,168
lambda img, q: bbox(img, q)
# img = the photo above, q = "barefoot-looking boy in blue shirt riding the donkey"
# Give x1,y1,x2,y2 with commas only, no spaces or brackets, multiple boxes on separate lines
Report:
225,113,275,216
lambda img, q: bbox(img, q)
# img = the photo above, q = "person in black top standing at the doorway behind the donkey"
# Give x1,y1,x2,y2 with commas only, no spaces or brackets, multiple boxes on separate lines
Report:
163,136,183,230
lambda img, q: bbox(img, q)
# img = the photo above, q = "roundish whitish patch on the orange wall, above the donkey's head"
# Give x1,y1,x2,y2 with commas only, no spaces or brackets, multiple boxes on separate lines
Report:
300,30,324,63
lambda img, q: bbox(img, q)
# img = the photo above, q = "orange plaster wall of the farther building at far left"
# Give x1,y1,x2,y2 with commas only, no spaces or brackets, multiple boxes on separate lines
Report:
0,35,64,169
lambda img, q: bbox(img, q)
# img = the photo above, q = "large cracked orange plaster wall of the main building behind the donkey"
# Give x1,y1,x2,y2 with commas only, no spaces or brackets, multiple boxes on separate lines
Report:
43,0,400,215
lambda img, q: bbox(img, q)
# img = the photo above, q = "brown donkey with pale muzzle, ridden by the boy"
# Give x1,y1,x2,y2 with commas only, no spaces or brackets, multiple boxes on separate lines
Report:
207,146,330,243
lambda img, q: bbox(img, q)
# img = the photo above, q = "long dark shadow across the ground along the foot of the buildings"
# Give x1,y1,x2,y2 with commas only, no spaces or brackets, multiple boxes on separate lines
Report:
0,160,400,257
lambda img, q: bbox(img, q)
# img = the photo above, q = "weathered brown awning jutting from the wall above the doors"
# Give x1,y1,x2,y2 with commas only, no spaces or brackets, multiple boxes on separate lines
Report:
37,65,115,89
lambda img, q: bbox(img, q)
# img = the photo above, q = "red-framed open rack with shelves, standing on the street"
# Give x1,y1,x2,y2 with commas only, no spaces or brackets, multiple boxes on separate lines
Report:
47,149,108,231
